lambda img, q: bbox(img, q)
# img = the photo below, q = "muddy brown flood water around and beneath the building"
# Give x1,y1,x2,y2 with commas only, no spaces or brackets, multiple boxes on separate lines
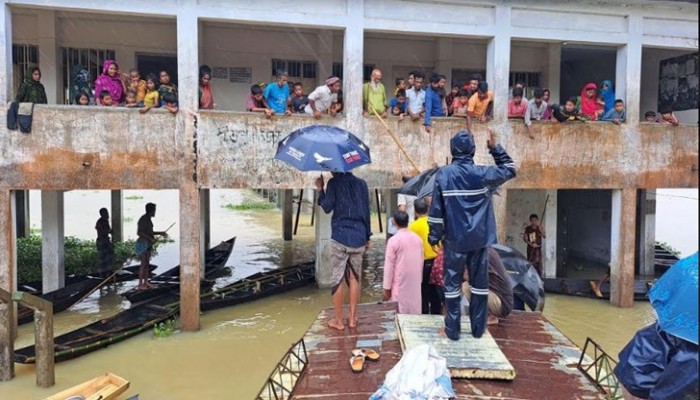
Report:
0,190,698,400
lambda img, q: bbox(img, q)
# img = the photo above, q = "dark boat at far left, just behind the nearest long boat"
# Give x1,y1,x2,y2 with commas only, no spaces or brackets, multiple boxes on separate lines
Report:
17,265,156,325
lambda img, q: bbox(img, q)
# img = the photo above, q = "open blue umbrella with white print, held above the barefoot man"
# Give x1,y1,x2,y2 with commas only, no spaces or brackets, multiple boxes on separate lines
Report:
275,125,372,172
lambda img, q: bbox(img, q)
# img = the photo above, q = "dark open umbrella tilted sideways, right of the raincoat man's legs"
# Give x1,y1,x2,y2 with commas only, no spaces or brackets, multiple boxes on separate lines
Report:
492,244,544,311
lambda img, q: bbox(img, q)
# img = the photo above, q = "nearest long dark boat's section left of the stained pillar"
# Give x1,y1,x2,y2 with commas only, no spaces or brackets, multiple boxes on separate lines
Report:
15,301,179,364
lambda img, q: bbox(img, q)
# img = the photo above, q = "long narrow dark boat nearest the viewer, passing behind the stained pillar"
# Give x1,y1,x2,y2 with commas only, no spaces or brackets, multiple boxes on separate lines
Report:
15,262,315,364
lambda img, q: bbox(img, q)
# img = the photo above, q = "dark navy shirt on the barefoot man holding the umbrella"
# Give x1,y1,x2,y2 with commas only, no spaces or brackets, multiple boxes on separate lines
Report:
318,173,372,248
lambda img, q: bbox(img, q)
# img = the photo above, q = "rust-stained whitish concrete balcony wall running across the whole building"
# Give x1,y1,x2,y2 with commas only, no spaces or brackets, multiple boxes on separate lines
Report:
0,106,698,190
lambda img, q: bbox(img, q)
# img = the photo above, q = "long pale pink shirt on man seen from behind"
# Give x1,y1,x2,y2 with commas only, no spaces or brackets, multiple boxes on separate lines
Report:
383,228,423,314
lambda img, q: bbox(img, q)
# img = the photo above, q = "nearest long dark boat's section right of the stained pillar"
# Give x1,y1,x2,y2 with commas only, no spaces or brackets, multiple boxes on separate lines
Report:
200,262,316,311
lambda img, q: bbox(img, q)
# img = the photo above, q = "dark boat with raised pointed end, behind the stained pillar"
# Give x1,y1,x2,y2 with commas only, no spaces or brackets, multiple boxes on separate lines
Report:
122,237,236,304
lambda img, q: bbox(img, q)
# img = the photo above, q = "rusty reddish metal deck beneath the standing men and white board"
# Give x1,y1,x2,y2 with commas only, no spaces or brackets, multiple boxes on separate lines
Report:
292,303,604,400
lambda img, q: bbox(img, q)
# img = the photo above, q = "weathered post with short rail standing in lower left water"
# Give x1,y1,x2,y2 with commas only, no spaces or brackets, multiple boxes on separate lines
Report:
12,292,56,388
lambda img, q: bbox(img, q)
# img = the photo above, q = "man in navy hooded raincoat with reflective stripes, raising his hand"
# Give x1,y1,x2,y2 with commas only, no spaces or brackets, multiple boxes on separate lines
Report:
428,129,515,340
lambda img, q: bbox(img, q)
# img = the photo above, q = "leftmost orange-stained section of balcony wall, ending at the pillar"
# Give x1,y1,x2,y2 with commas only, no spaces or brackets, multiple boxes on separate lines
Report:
0,105,182,190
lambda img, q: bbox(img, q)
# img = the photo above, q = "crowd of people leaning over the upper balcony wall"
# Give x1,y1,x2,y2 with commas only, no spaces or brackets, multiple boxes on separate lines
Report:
15,65,679,128
